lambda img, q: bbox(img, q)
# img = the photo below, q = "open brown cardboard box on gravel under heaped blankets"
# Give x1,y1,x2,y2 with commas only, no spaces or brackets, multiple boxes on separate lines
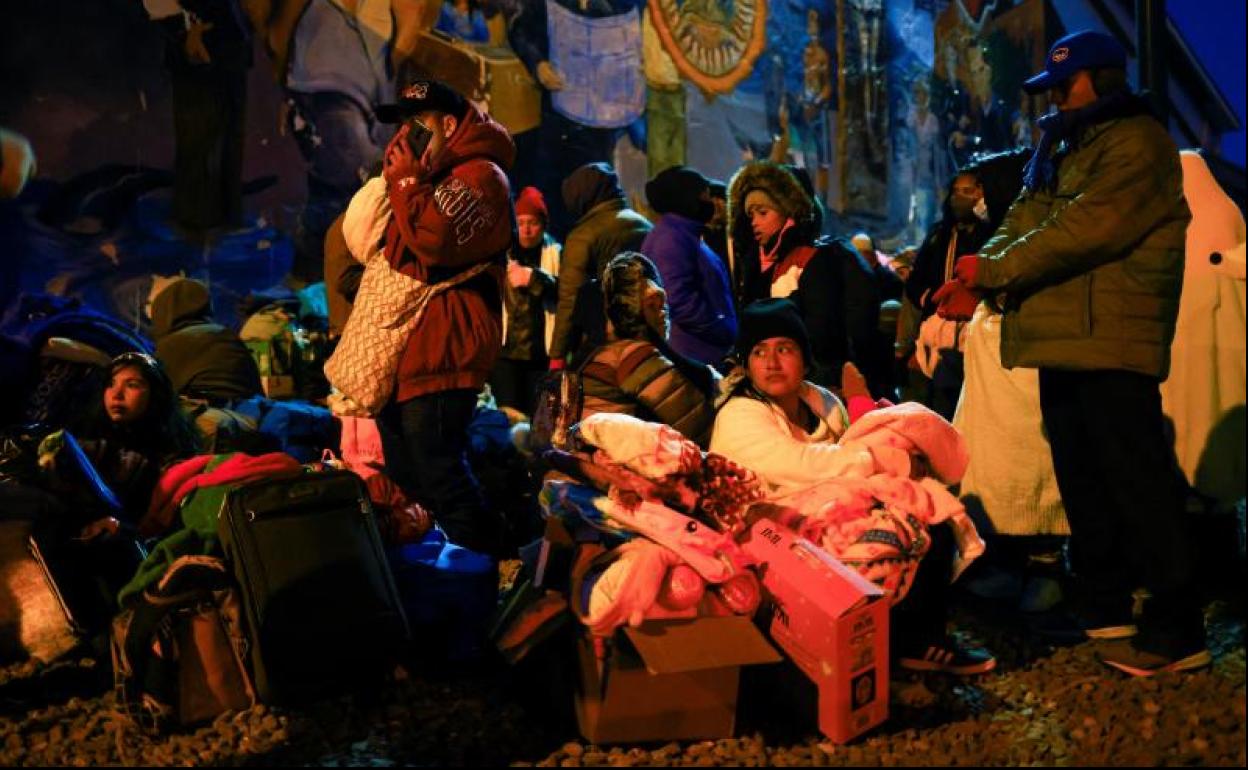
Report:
575,615,780,745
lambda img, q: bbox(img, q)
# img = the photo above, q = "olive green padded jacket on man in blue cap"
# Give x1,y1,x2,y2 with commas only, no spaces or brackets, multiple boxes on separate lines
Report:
976,108,1192,379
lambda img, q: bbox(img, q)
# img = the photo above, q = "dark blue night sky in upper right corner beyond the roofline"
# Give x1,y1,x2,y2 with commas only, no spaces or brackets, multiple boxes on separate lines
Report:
1166,0,1246,166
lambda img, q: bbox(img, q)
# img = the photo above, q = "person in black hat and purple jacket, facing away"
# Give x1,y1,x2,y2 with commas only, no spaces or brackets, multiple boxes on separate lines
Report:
641,166,736,364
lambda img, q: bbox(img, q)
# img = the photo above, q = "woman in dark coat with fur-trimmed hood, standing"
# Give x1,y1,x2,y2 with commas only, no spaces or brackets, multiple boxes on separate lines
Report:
728,161,887,396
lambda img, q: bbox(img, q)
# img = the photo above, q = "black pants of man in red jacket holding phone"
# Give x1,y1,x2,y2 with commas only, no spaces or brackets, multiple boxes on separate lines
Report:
399,389,502,553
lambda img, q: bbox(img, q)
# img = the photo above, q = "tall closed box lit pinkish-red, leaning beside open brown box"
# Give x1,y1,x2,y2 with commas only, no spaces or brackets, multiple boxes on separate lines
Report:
741,519,889,744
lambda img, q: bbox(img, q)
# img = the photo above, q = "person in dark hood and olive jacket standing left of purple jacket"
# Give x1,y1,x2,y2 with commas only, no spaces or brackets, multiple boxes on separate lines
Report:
550,163,650,366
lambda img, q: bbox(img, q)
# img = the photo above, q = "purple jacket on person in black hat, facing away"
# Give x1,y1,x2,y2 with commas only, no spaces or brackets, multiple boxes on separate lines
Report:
641,213,736,364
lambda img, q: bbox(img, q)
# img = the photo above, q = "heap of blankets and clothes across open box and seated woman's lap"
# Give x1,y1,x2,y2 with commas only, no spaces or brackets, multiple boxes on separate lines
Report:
531,404,983,635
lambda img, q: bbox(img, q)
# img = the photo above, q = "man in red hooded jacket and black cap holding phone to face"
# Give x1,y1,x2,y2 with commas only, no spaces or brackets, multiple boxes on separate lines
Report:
376,80,515,553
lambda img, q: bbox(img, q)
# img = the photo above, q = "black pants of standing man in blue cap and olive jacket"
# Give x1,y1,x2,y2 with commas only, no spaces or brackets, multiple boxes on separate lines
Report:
1040,369,1204,654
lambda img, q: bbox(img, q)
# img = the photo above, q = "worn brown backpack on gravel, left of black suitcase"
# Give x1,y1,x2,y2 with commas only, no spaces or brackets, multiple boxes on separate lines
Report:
110,555,256,731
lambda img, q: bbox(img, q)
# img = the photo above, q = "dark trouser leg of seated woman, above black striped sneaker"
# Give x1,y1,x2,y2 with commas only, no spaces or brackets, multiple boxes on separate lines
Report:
889,524,957,656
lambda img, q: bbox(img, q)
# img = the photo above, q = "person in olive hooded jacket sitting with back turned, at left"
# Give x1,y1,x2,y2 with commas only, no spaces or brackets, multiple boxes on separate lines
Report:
151,278,263,406
